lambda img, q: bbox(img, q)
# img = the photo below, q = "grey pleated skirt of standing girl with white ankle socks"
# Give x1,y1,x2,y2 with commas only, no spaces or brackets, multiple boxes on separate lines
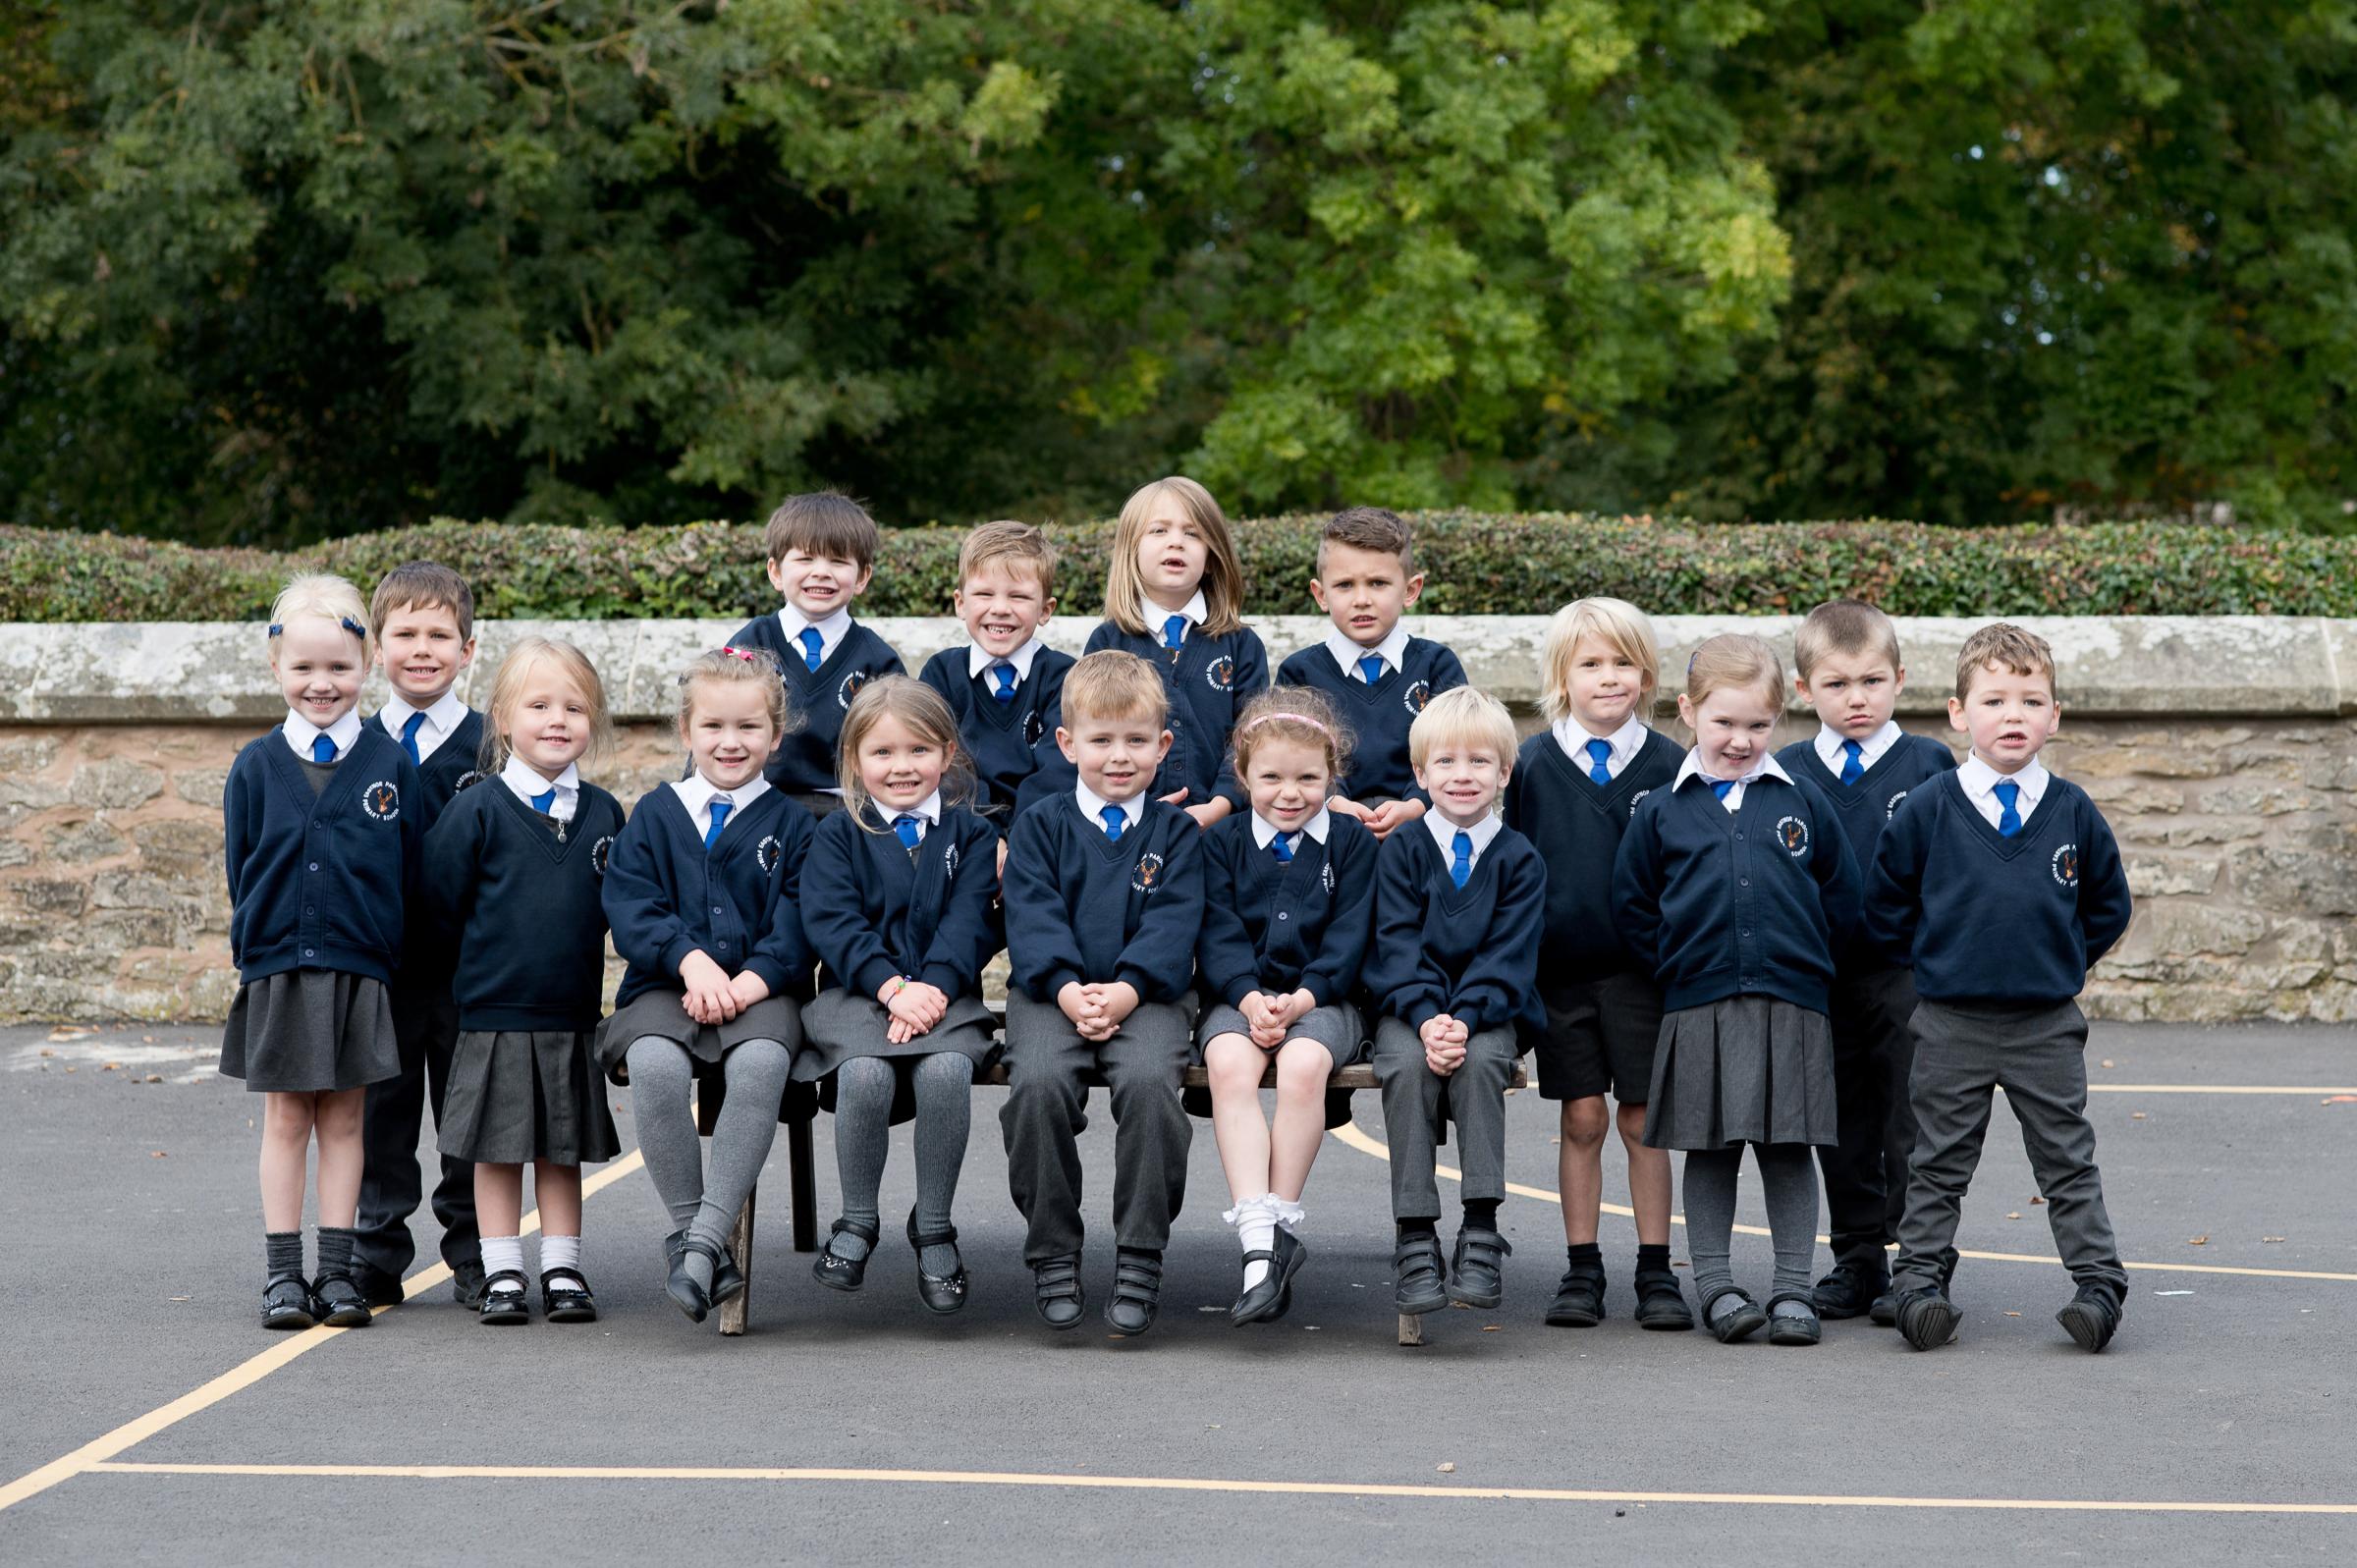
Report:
436,1028,623,1164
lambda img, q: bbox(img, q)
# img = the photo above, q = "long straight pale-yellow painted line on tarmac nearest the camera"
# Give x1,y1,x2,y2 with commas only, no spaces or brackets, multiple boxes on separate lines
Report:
74,1464,2357,1514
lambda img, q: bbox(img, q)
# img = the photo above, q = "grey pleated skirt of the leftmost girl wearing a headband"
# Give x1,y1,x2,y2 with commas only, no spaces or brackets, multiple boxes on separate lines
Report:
222,969,401,1094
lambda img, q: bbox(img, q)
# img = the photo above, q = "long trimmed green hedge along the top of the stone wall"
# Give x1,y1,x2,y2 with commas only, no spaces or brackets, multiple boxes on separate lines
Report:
0,512,2357,621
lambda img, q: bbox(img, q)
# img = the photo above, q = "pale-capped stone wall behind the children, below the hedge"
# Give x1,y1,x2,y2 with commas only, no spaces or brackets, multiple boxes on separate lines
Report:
0,618,2357,1021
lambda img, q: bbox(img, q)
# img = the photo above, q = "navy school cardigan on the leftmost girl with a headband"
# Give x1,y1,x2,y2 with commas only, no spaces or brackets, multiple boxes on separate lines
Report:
222,724,424,986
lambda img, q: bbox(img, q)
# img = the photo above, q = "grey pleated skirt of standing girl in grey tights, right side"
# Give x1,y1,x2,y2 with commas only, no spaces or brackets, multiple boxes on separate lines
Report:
1645,995,1840,1151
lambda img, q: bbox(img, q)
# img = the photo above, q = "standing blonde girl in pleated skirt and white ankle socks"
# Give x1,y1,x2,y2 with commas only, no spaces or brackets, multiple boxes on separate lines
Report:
426,636,623,1323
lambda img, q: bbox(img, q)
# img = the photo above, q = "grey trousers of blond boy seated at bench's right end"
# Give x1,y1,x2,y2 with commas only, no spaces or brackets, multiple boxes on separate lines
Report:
1374,1016,1520,1219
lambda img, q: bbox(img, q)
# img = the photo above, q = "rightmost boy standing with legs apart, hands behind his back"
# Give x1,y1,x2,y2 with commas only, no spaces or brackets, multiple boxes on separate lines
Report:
1867,622,2133,1351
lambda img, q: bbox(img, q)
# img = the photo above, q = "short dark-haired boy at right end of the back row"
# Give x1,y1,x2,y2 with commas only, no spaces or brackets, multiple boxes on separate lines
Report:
1278,507,1466,841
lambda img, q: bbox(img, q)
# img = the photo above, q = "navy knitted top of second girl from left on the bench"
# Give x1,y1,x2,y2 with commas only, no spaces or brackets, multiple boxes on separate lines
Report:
801,806,1004,1000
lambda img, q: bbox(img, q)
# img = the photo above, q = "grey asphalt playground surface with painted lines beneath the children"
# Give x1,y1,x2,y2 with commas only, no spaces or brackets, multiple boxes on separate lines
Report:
0,1026,2357,1566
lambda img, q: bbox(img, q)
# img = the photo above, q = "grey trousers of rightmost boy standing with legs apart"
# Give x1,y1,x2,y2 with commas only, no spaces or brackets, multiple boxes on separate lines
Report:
1891,1000,2128,1302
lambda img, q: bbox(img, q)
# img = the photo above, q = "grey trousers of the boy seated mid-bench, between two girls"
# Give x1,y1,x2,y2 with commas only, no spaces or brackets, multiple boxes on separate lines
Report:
1000,986,1195,1269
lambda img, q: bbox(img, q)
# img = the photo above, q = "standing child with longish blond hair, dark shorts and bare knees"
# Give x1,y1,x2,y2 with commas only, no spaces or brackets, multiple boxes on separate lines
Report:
1507,599,1695,1329
